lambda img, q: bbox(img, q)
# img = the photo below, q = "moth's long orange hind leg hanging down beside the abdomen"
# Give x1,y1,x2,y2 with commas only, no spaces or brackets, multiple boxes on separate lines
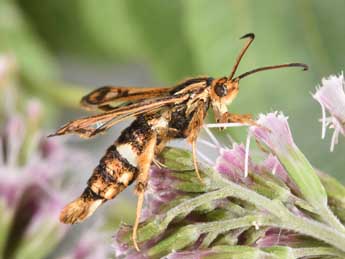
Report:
132,133,157,251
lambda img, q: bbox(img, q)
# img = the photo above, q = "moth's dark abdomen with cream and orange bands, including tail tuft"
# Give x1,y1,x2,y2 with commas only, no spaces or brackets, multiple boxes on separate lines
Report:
60,117,152,224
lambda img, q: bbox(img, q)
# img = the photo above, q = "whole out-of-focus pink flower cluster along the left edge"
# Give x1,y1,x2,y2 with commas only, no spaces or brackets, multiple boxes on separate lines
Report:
0,57,108,259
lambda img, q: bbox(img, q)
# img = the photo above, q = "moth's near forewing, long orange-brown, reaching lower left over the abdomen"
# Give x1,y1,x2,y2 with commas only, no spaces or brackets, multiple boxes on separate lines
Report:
50,94,189,138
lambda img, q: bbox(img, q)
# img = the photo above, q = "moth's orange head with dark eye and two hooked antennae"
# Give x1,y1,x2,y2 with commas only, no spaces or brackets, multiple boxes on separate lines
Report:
210,33,308,122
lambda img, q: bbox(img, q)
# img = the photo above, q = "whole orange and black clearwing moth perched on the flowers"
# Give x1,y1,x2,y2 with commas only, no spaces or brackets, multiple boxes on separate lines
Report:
51,33,308,250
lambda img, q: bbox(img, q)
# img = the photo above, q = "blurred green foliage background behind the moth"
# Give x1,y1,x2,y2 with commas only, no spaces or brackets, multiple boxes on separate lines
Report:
0,0,345,258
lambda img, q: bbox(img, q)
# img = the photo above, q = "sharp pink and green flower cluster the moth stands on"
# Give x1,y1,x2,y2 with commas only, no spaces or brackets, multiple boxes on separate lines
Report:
115,113,345,259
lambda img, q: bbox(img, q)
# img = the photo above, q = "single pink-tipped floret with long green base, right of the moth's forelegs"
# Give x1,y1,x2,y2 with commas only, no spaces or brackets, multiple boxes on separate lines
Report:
250,112,327,206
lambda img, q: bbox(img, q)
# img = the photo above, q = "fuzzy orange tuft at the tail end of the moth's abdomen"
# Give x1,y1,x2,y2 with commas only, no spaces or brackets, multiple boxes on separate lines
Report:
60,197,103,224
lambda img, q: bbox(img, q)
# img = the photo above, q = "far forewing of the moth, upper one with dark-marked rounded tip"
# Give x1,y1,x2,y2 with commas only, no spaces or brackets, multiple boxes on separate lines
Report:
81,86,170,111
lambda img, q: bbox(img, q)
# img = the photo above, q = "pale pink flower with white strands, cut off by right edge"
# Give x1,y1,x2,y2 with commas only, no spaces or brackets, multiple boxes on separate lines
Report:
313,73,345,152
